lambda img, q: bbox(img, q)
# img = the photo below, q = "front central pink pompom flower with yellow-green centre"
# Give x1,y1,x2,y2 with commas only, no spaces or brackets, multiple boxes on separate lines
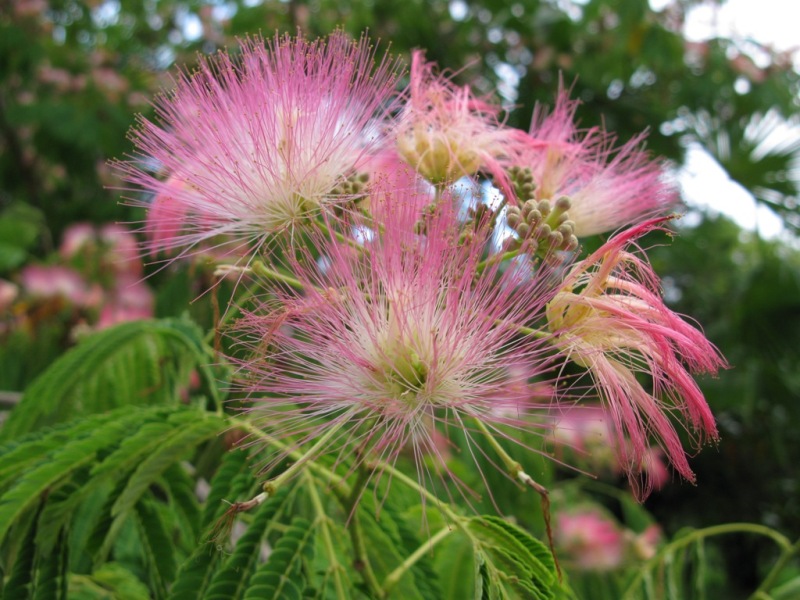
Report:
236,192,555,496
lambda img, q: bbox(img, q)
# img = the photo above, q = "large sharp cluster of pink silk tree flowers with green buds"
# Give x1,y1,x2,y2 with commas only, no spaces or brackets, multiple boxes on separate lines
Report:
118,33,724,502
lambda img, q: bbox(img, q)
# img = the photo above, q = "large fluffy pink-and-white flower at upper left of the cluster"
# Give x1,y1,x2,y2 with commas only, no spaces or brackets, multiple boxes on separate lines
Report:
117,32,398,255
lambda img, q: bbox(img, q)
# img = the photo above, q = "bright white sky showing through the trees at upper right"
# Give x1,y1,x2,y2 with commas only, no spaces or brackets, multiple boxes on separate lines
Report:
672,0,800,238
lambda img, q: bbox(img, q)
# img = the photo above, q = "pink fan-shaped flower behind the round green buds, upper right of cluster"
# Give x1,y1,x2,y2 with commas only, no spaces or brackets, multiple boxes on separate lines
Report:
516,92,678,237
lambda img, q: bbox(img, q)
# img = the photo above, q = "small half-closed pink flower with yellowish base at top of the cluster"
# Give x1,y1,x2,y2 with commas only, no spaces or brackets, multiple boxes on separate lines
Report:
395,51,522,190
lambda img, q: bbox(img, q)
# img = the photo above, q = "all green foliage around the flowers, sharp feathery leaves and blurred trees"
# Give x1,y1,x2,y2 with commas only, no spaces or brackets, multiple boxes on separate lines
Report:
0,0,800,600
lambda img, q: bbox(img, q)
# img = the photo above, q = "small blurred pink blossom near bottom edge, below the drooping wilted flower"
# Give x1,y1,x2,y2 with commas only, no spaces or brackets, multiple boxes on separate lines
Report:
554,510,625,571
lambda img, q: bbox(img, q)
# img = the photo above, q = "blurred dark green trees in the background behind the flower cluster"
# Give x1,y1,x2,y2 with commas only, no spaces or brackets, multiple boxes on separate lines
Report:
0,0,800,597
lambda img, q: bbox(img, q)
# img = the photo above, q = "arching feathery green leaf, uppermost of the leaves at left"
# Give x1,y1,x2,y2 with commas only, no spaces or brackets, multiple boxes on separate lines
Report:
0,319,208,440
